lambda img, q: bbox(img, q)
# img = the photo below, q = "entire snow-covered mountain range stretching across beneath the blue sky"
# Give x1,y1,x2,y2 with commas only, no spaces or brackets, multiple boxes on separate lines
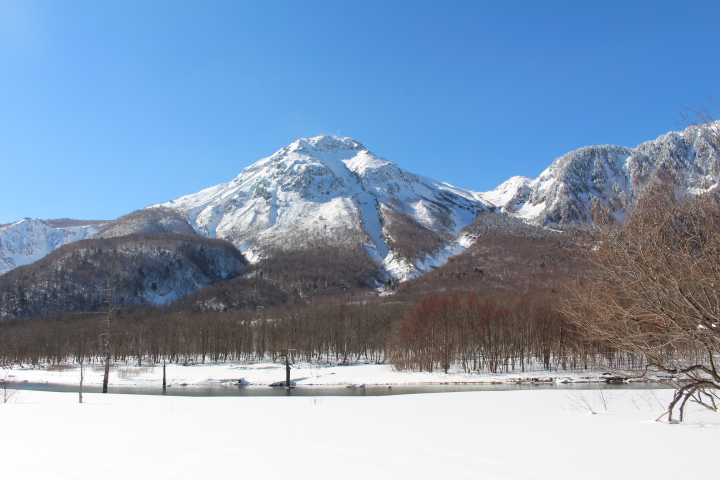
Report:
5,127,720,280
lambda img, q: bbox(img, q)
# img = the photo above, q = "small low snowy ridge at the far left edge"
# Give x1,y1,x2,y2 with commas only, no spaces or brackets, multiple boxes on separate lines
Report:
0,218,101,275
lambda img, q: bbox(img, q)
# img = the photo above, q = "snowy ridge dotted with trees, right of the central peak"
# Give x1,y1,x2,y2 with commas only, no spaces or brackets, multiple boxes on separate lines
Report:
481,127,720,225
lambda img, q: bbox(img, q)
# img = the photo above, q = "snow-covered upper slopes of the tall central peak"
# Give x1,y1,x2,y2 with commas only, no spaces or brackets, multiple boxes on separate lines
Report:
148,135,487,280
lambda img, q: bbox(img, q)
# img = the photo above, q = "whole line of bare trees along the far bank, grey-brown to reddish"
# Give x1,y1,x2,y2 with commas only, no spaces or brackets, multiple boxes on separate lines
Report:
0,284,620,373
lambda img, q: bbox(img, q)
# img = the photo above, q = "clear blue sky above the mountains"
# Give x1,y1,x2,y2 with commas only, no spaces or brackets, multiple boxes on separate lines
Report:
0,0,720,223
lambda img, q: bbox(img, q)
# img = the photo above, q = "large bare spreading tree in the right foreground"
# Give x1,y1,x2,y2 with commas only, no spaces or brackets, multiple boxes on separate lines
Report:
567,178,720,422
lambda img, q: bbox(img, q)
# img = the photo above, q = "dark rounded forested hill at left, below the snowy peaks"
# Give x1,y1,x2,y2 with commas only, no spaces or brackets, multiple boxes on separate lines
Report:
0,233,246,318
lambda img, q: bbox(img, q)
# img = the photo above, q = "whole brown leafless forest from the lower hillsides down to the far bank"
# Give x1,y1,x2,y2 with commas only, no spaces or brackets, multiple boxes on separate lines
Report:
0,214,615,372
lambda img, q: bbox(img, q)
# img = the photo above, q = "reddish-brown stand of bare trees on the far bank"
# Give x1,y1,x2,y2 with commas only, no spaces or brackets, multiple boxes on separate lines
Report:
394,292,638,373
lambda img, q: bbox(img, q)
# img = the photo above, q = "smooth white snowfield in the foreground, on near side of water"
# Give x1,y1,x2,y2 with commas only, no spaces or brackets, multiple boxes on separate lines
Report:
0,367,720,480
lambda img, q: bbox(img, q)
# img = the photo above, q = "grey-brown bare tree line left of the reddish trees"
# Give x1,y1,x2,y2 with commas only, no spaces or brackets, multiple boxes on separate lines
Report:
0,302,405,365
